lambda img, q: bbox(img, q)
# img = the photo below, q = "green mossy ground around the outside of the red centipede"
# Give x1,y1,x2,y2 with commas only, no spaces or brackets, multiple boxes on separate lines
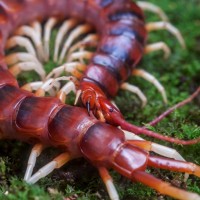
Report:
0,0,200,200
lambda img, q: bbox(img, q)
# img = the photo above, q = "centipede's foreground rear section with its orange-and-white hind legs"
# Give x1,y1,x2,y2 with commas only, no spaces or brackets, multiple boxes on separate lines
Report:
0,77,200,200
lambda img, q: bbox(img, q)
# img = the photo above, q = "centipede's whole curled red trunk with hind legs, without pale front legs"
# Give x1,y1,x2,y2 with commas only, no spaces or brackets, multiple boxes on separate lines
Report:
0,0,200,200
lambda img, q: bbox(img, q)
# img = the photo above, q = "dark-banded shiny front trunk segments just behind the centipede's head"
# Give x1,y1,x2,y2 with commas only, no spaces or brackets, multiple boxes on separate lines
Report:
81,1,147,97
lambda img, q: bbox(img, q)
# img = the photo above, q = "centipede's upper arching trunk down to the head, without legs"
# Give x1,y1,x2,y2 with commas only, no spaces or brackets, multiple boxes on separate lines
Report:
0,0,147,115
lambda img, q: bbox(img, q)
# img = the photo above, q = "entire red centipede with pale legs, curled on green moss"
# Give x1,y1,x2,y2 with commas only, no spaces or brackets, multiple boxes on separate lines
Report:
0,0,200,200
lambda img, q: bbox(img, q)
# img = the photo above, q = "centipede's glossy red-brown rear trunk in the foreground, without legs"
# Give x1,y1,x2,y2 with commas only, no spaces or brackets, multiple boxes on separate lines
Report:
0,83,148,173
